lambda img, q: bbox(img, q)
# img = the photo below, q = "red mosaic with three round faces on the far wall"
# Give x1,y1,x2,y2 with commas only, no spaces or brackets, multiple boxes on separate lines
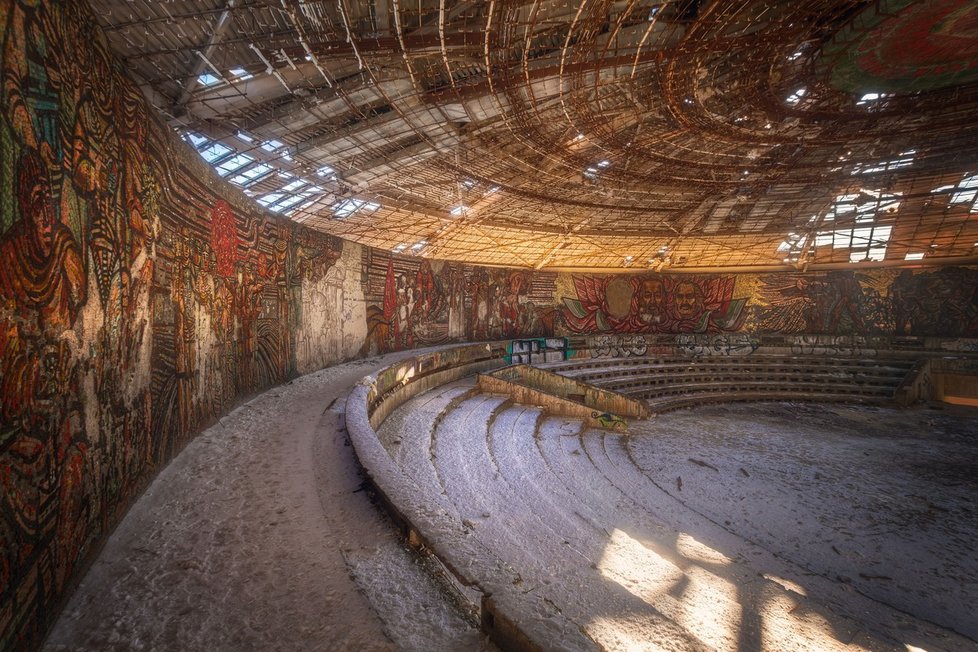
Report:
562,275,747,333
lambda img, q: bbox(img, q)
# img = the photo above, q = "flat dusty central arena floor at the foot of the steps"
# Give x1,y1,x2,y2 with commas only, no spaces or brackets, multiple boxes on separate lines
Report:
625,403,978,640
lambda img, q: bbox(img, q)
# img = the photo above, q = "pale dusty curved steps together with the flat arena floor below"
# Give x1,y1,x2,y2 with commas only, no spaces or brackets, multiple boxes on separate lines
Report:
380,384,978,652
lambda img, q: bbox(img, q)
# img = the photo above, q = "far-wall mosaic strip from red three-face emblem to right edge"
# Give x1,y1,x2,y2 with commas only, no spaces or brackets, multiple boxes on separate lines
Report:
555,267,978,337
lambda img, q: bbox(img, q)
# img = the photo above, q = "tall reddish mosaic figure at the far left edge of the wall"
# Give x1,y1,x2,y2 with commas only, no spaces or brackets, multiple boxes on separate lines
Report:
0,149,88,620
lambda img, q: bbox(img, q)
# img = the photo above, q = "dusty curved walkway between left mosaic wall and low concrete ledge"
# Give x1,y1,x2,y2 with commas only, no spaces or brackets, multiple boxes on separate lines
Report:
45,354,488,651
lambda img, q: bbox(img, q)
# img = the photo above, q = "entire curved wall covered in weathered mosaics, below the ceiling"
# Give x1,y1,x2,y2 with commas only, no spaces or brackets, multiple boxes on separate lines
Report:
0,0,978,649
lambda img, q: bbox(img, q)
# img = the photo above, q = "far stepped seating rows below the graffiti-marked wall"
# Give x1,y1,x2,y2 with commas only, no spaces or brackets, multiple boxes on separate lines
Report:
532,355,914,412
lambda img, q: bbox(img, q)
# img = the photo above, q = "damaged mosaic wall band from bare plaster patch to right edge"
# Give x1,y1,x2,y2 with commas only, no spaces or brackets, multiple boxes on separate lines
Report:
362,258,978,353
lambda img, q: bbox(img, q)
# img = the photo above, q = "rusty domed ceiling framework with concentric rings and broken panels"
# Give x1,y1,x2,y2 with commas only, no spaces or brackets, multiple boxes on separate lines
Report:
92,0,978,270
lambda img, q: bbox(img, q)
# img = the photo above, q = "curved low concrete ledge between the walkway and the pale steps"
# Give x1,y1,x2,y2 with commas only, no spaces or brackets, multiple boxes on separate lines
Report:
346,347,599,651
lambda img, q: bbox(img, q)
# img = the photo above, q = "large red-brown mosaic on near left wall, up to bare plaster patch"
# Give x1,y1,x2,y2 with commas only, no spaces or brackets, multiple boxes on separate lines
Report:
0,2,350,649
